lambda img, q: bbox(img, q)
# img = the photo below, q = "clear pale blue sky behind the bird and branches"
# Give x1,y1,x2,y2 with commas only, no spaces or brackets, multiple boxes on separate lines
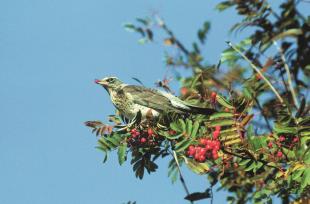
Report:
0,0,308,204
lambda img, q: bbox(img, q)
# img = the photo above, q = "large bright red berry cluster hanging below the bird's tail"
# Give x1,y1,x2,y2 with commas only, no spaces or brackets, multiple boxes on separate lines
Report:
187,126,221,162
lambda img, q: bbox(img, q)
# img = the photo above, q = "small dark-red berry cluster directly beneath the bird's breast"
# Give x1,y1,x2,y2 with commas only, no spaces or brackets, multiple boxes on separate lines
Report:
127,128,160,147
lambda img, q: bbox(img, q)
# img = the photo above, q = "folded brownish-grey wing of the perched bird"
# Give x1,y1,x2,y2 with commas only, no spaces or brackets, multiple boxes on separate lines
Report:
123,85,184,112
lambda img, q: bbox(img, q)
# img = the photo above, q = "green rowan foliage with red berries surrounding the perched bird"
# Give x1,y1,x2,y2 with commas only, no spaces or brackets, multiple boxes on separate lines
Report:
86,0,310,203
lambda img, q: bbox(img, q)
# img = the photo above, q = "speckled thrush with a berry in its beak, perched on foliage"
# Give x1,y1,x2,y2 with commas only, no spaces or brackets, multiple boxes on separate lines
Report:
95,77,215,120
